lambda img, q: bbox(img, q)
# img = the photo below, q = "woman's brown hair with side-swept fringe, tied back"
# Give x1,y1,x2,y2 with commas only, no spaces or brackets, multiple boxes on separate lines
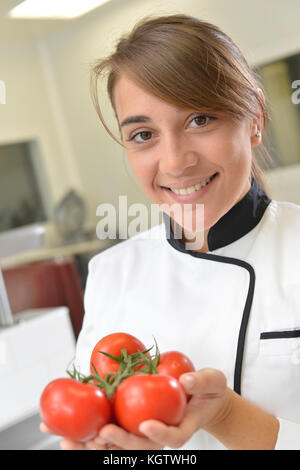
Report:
91,15,271,189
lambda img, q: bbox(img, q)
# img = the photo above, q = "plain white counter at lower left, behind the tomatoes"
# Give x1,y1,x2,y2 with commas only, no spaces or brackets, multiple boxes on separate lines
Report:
0,307,75,431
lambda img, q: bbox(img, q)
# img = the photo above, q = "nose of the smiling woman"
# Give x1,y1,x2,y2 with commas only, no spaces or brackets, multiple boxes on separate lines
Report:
159,135,198,177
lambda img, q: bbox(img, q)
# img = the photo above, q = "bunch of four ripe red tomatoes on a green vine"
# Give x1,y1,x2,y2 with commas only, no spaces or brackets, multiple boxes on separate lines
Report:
40,333,195,442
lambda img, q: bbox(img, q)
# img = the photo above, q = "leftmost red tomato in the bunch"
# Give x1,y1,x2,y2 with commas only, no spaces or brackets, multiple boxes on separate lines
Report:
40,378,112,442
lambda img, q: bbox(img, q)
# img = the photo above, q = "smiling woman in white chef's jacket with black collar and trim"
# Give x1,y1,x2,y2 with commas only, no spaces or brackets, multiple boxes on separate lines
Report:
41,15,300,449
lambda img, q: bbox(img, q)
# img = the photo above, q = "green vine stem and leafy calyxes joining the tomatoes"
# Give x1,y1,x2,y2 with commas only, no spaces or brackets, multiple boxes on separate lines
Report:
67,338,160,398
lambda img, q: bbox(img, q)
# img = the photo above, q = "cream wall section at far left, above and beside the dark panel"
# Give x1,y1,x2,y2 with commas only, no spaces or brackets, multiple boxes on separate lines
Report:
0,43,82,211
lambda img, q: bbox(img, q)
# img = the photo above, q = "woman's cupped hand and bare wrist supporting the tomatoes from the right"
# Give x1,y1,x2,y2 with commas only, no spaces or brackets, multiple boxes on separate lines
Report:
92,369,279,450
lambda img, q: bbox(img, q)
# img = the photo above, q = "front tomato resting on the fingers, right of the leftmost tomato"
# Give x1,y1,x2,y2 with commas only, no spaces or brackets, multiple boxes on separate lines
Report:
114,374,187,436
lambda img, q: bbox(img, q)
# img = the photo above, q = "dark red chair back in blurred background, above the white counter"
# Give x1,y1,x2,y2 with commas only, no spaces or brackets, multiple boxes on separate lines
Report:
2,259,84,339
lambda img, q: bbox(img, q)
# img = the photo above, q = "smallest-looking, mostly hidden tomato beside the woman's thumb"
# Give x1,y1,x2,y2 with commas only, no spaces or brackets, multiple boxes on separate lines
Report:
157,351,195,379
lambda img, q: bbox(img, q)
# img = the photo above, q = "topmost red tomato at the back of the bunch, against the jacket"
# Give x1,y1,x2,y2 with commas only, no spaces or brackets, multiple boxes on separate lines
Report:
90,333,146,379
